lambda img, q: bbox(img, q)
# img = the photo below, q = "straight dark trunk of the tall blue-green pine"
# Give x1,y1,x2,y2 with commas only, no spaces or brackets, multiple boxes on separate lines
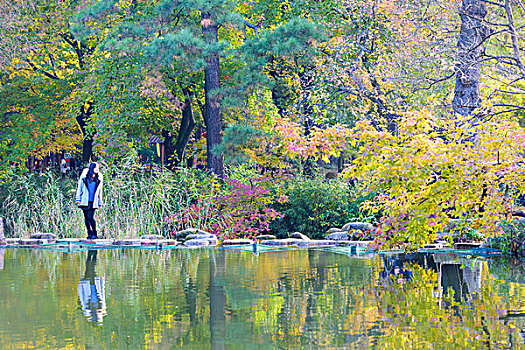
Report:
201,12,224,179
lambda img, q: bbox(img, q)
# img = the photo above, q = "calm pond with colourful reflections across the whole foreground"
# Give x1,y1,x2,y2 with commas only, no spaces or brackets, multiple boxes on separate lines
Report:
0,249,525,349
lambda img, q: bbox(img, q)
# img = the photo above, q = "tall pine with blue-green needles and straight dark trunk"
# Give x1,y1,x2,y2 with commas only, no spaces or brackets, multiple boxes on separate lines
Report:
70,0,315,177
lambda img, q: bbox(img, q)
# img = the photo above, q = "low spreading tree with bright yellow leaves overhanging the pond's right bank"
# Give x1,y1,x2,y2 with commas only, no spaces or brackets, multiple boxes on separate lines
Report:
347,111,525,249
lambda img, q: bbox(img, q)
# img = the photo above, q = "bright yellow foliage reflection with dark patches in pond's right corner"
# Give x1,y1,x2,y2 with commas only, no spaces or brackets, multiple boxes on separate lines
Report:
374,254,525,349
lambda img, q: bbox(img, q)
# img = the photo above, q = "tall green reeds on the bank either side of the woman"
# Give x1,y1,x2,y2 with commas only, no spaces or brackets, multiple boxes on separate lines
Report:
0,168,210,238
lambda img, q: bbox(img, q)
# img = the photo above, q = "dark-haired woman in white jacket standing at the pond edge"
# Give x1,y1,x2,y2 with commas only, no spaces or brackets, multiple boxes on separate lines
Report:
75,163,103,239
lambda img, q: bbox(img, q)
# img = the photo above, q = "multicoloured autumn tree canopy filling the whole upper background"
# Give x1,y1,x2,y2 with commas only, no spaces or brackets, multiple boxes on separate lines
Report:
0,0,525,245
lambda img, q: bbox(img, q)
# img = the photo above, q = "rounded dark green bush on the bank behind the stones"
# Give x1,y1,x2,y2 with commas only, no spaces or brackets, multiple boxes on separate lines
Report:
270,178,379,238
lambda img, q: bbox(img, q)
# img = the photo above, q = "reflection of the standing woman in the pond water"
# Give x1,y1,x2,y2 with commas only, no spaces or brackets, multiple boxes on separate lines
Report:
78,250,107,325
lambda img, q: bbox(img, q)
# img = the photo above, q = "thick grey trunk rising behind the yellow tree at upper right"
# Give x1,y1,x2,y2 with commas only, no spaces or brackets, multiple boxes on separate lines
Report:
452,0,487,115
